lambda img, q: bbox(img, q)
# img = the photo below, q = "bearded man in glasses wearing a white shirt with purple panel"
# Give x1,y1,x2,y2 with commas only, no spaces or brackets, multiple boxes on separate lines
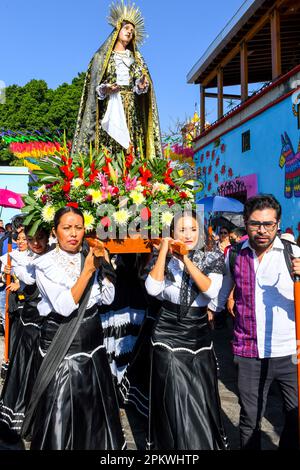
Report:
210,194,300,449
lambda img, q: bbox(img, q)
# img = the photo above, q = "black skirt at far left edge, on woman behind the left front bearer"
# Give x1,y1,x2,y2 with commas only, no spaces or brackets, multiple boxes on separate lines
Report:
0,299,43,441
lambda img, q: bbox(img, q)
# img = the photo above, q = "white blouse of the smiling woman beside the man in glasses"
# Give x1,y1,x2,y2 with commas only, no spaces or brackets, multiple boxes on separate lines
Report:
145,258,223,307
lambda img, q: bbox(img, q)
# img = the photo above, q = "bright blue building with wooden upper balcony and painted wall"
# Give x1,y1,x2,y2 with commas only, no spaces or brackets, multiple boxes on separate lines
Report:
187,0,300,236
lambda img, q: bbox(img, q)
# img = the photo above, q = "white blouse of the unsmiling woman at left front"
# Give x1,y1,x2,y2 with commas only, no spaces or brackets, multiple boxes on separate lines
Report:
34,249,115,317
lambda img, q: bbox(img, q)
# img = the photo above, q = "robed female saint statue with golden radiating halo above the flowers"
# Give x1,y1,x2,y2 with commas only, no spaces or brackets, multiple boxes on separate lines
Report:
72,3,162,158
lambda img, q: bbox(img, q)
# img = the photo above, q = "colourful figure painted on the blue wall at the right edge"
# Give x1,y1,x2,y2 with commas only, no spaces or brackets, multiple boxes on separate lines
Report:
279,132,300,199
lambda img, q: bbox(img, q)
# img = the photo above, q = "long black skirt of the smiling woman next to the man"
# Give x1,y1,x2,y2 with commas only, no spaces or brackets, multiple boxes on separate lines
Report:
148,302,227,450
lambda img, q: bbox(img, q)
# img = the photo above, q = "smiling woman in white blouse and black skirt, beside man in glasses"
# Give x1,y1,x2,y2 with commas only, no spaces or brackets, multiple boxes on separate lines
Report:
145,213,227,450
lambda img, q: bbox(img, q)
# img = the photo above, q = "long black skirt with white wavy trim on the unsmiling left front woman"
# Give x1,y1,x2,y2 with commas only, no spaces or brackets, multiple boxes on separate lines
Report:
31,306,125,450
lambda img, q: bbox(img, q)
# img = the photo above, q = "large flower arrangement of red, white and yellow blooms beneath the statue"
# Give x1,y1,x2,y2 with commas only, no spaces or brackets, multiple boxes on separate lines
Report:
22,145,194,239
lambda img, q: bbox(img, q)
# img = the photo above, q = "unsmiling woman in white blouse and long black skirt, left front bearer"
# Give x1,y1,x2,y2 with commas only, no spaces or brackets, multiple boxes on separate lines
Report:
22,206,125,450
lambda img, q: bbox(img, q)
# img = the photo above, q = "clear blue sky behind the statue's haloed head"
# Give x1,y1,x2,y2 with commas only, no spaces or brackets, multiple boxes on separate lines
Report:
0,0,243,132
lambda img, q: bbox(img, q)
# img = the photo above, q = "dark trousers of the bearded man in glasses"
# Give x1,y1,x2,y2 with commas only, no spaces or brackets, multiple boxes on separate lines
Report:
234,356,298,449
